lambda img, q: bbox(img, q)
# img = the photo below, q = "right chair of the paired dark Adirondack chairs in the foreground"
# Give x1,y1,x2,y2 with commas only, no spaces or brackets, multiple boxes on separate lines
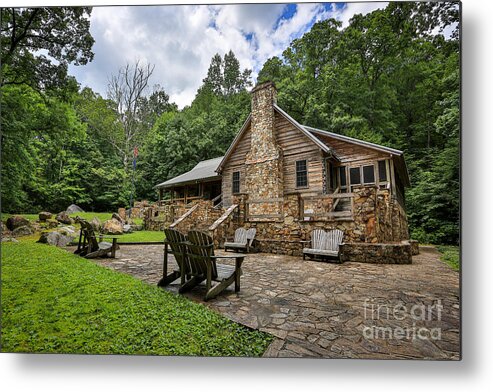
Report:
180,231,245,301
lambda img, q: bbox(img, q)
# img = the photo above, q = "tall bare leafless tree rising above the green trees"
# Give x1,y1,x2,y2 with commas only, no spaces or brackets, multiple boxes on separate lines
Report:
108,60,154,171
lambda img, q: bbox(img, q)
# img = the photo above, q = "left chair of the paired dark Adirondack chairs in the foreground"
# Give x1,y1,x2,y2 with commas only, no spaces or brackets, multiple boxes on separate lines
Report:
157,229,190,287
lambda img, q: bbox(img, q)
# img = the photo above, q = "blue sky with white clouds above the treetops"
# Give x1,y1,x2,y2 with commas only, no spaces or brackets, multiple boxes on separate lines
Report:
69,2,387,109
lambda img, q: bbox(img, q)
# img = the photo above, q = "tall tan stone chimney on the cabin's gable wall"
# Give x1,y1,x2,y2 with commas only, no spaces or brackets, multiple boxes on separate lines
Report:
245,82,283,219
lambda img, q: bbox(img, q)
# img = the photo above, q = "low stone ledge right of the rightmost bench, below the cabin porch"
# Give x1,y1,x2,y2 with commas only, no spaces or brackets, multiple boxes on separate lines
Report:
339,242,412,264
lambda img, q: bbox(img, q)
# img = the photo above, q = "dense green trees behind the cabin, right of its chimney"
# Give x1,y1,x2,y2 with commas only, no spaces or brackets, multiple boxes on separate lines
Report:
258,3,460,244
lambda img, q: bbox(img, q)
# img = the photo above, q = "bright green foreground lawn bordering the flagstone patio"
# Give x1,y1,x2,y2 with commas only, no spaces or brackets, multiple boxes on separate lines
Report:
1,240,272,356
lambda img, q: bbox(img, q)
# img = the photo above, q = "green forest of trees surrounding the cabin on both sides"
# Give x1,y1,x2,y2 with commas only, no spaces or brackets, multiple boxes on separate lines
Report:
0,2,460,244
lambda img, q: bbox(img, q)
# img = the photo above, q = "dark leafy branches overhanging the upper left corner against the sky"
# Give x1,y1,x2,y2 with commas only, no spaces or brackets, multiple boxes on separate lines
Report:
0,7,94,90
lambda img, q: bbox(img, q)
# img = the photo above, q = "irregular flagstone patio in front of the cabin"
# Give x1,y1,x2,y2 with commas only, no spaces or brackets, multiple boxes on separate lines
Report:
86,245,460,360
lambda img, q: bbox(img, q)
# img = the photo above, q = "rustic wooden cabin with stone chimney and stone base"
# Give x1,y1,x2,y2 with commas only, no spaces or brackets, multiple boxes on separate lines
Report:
158,82,410,250
